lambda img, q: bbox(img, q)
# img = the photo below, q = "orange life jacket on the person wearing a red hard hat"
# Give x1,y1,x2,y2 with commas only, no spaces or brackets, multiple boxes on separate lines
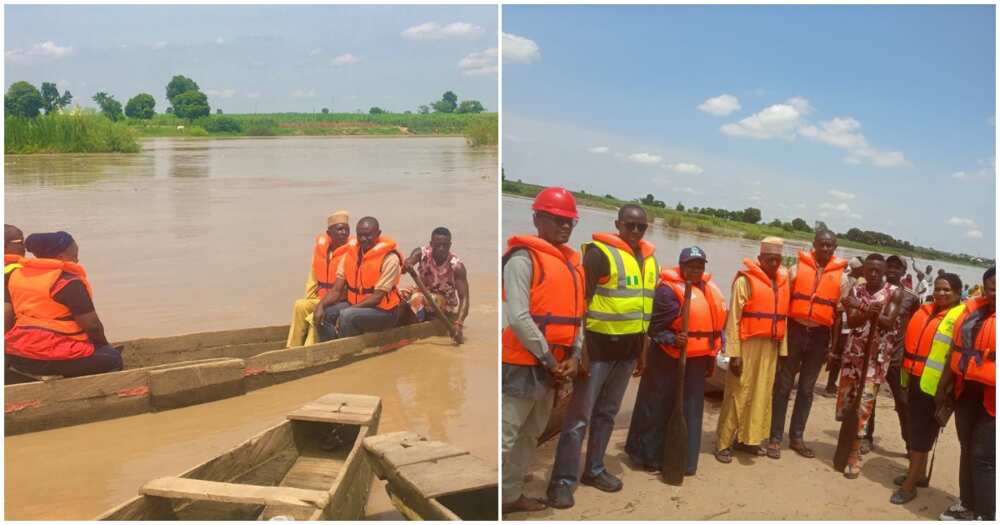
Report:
501,235,586,365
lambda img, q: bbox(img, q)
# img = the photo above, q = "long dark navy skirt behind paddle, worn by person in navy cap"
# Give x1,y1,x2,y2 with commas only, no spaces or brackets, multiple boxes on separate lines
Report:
625,346,715,472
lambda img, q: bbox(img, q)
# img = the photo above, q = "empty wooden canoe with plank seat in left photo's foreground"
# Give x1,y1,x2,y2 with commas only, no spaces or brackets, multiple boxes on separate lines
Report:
97,394,382,521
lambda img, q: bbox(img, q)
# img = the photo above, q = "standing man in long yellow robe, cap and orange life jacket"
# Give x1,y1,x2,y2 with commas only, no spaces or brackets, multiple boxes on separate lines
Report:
715,237,791,463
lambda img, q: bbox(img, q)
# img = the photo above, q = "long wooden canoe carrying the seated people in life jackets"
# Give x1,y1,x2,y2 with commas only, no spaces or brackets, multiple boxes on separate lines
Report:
4,322,444,436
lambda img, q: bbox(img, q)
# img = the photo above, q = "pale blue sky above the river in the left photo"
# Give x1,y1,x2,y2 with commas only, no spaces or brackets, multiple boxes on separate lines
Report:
4,5,498,113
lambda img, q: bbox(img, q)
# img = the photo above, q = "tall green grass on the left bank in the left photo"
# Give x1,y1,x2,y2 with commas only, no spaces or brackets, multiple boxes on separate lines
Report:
4,113,139,154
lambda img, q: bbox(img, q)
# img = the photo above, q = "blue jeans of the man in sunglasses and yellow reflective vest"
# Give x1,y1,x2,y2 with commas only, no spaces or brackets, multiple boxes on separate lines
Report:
549,358,635,487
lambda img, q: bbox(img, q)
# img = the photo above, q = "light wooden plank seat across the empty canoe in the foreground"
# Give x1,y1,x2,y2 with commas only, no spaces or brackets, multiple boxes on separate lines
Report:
139,477,330,511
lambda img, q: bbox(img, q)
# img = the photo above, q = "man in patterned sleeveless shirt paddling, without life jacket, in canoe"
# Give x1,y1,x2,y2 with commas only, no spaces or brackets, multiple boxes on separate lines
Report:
399,226,469,341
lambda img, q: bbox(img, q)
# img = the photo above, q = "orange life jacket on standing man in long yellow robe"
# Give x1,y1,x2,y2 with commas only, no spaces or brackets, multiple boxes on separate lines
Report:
736,258,790,341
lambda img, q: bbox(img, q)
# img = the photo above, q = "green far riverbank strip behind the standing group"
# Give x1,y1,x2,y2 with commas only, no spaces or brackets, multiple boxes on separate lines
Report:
502,175,995,267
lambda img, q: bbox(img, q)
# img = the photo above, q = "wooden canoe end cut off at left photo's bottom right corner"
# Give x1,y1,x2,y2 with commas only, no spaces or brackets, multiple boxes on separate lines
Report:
364,432,499,521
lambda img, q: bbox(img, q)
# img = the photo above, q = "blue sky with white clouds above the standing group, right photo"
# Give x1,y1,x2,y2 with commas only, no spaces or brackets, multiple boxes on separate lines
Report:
503,5,996,257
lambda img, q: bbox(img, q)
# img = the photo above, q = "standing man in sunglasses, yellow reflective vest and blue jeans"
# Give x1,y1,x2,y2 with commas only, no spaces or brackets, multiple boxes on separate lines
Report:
548,204,657,509
